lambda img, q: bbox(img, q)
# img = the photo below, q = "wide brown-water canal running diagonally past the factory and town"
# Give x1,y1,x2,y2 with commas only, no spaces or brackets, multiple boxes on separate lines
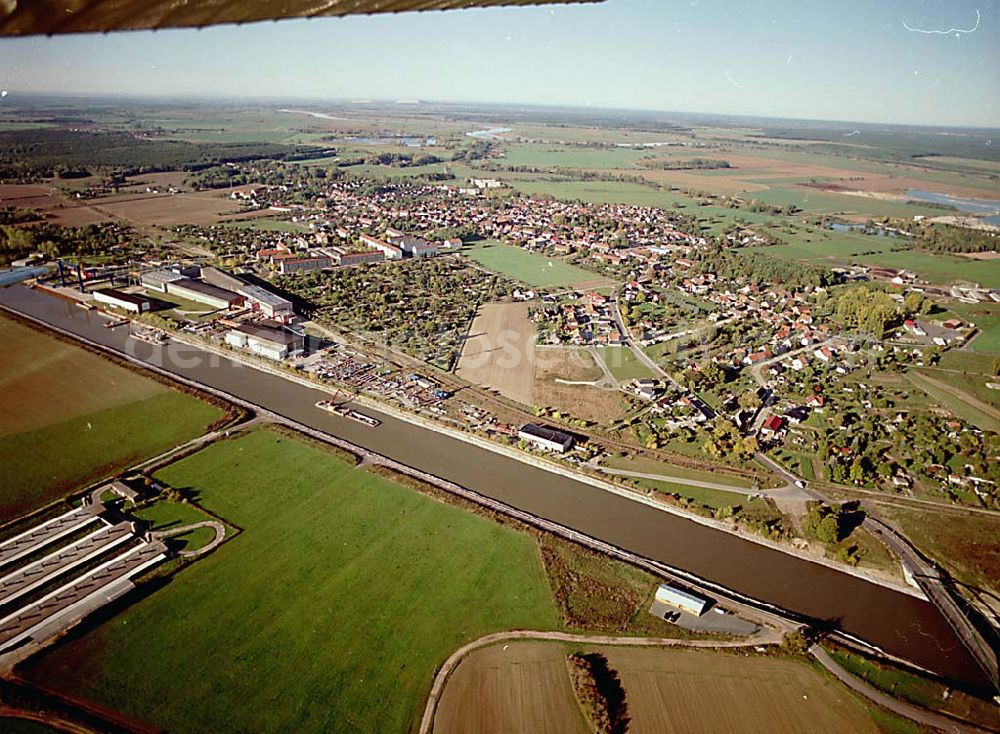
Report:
0,285,985,686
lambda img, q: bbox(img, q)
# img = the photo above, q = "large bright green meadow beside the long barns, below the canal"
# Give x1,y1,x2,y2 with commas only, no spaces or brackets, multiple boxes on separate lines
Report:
25,430,560,732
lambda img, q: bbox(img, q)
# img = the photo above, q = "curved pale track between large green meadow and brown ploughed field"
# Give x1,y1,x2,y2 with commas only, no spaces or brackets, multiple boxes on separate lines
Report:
420,629,781,734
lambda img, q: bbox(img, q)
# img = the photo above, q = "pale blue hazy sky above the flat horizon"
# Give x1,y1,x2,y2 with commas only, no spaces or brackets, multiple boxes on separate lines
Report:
0,0,1000,127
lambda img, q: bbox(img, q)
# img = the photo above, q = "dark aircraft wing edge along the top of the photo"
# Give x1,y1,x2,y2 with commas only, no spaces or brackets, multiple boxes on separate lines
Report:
0,0,600,36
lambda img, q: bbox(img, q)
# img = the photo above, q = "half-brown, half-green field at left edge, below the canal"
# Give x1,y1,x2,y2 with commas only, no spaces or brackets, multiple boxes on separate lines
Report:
0,319,223,520
